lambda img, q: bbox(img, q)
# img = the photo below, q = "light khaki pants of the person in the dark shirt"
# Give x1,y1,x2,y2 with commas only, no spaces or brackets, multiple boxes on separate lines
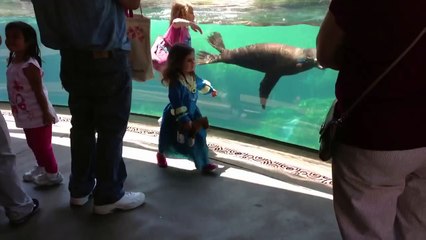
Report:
332,144,426,240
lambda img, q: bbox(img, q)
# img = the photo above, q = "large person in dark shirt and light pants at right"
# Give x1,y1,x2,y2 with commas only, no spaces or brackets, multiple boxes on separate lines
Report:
316,0,426,240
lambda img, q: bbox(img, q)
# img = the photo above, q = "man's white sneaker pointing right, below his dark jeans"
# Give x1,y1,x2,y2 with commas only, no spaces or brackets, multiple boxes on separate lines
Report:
93,192,145,215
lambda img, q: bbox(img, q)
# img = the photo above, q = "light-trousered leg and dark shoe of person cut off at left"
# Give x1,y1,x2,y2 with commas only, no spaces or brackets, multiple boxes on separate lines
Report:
0,112,34,219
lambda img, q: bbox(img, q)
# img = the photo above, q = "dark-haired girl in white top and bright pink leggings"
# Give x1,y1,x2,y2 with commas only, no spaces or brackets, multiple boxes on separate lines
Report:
5,22,63,186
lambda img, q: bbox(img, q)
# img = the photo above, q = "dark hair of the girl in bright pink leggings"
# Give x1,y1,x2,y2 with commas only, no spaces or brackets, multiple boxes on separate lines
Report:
5,21,41,66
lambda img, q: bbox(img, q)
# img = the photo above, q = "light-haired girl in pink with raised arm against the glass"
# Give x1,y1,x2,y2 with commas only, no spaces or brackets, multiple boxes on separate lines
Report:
151,1,203,73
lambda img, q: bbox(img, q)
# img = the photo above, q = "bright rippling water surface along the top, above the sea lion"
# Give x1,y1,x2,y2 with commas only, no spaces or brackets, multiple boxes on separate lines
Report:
142,0,330,26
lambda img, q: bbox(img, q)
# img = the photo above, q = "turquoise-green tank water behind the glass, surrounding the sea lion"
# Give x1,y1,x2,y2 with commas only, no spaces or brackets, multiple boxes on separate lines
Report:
0,17,336,149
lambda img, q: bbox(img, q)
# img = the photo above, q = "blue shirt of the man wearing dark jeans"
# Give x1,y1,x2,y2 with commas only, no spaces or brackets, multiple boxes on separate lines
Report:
32,0,130,50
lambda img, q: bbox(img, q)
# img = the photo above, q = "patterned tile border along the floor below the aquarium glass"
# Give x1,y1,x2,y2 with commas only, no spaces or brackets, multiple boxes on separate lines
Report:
2,110,333,187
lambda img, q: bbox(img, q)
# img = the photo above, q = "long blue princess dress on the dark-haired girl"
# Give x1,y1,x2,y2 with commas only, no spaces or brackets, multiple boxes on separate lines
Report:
158,75,214,170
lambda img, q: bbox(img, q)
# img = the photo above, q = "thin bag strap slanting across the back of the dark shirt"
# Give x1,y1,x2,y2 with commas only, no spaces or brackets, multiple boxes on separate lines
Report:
337,27,426,123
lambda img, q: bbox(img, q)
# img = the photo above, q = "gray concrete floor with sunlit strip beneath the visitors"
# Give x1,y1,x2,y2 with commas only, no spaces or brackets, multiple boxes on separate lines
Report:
0,108,340,240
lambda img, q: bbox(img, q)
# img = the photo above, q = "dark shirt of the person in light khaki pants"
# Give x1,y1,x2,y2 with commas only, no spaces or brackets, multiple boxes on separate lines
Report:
330,0,426,150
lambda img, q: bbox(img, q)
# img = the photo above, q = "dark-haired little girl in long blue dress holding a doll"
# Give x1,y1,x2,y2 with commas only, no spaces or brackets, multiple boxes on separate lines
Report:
157,44,217,172
